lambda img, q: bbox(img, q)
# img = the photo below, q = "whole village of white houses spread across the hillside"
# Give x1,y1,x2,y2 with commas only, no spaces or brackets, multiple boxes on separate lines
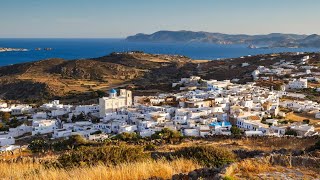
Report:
0,52,320,151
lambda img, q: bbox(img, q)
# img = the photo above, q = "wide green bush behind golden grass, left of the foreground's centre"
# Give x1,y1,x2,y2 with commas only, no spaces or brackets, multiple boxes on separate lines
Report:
57,145,150,168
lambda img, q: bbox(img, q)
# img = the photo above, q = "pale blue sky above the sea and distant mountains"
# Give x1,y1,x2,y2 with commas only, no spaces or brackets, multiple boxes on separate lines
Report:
0,0,320,38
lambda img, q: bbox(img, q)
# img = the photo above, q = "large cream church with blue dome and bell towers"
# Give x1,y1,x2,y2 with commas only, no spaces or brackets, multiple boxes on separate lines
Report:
99,89,132,117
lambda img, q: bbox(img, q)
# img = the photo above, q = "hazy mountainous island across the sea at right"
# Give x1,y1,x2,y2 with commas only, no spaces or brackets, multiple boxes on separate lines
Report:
126,31,320,48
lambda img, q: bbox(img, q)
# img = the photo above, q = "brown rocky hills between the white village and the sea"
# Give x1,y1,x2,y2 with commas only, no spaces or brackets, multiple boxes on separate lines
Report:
0,52,319,102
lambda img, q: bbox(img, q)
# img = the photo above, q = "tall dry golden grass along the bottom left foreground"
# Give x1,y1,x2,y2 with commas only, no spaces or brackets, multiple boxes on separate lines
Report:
0,159,200,180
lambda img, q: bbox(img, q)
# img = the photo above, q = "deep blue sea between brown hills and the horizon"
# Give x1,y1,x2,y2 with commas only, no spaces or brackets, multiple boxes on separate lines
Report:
0,39,320,66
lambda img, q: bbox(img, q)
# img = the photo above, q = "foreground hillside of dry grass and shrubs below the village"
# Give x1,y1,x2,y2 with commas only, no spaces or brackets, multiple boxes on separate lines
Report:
0,135,320,180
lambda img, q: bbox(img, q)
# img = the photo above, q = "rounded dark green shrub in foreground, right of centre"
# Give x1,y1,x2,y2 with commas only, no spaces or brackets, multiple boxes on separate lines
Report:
173,146,236,167
